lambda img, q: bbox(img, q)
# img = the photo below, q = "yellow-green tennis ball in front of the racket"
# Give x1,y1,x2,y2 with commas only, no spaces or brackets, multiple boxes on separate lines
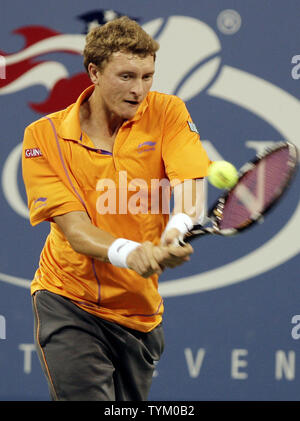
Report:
208,161,238,189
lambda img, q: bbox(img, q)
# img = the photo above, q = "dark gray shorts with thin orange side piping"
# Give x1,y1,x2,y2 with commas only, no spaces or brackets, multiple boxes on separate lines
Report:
33,290,164,401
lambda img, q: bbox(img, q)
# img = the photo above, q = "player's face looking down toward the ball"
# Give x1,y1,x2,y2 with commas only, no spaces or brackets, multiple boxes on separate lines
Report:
96,52,154,120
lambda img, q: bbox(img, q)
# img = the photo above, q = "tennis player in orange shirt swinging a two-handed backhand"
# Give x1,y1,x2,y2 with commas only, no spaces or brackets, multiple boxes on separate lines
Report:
22,17,210,401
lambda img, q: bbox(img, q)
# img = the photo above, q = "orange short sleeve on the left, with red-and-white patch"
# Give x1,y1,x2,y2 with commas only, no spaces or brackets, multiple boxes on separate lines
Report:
22,127,85,225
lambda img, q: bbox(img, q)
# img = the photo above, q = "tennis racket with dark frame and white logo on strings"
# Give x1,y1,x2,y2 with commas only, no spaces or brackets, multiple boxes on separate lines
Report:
184,142,298,242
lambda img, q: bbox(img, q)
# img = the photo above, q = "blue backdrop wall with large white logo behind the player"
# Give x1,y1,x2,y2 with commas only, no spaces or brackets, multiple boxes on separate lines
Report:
0,0,300,401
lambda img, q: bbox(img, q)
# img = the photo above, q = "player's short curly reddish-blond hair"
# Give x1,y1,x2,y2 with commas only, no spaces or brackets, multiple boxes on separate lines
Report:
83,16,159,72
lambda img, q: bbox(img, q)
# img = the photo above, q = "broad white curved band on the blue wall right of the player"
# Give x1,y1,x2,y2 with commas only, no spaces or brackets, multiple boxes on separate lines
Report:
159,66,300,297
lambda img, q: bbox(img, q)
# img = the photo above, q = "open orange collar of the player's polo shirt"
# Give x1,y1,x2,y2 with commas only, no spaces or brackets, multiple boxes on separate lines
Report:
58,85,148,142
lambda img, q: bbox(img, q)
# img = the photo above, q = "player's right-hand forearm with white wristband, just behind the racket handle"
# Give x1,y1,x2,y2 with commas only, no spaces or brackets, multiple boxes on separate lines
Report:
161,179,206,245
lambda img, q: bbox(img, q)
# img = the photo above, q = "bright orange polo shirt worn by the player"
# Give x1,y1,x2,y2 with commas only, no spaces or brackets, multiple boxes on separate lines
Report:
22,86,210,332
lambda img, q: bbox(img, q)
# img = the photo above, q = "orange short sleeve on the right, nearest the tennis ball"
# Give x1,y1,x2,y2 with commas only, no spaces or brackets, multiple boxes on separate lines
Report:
162,96,210,184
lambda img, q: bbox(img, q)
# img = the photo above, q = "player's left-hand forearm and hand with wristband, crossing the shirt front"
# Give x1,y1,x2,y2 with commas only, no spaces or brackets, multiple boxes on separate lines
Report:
53,211,188,278
